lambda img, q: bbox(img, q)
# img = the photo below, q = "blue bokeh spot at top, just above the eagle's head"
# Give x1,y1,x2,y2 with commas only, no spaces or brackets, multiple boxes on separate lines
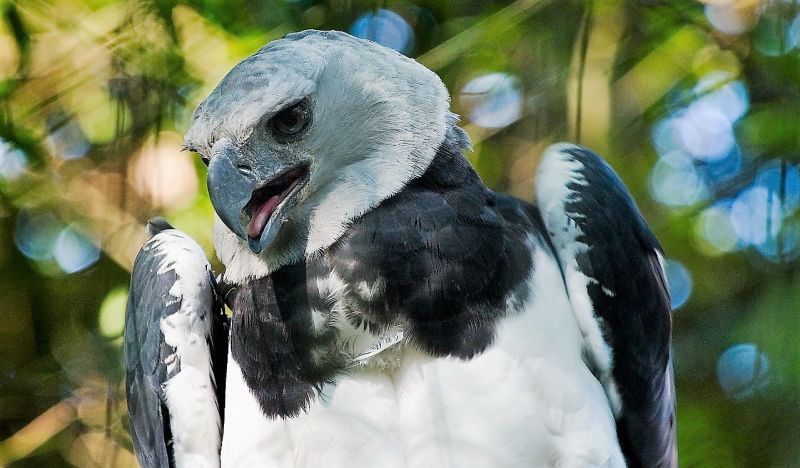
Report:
350,8,415,55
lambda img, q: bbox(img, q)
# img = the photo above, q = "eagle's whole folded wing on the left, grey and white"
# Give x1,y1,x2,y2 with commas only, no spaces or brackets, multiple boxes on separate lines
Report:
125,226,228,468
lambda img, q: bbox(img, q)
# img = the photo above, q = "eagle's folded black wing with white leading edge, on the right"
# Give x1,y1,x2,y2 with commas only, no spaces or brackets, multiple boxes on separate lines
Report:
536,144,677,467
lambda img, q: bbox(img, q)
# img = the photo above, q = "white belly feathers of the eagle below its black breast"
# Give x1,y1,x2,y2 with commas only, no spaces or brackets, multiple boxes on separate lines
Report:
222,243,625,468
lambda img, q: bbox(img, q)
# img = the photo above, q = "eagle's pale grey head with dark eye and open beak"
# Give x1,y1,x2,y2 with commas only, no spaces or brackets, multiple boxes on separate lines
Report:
185,31,449,277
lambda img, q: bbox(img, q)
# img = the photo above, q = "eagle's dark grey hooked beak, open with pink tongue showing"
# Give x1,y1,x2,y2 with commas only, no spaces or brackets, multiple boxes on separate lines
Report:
208,141,308,254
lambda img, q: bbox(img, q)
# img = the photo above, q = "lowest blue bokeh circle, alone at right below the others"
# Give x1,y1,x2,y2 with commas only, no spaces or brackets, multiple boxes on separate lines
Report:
717,343,772,400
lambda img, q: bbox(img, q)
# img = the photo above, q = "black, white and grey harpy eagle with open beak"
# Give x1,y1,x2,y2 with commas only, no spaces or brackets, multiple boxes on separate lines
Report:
125,31,677,468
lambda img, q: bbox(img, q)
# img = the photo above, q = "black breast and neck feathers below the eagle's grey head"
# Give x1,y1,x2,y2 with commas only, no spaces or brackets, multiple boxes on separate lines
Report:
231,127,544,416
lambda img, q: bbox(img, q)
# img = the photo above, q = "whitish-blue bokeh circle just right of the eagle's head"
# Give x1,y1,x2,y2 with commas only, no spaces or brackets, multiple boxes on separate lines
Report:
459,72,522,128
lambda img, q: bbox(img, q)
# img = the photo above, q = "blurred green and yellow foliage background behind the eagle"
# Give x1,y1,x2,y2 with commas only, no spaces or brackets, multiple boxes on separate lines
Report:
0,0,800,467
